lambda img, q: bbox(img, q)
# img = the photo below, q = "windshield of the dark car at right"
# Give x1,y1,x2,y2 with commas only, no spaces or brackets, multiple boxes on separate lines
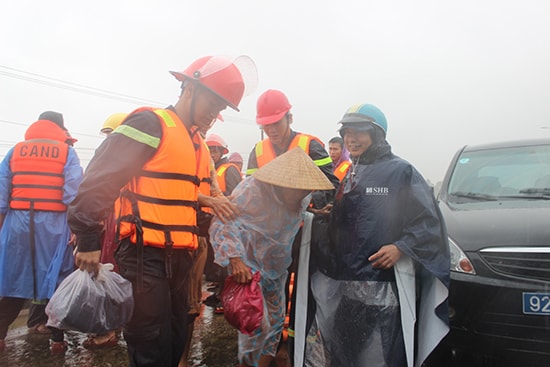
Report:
448,145,550,199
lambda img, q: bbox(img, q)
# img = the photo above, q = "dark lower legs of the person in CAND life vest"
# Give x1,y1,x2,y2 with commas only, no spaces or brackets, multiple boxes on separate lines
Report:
0,297,64,342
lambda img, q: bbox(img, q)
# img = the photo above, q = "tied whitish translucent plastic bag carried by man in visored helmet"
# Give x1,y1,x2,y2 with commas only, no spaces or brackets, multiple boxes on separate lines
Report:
46,264,134,333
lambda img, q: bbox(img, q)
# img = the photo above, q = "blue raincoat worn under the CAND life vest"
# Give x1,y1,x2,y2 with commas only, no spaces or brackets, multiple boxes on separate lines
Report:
0,147,82,301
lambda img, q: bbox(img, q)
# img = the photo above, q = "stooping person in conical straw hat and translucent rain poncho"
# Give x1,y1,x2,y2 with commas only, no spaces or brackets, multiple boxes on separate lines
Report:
210,148,333,367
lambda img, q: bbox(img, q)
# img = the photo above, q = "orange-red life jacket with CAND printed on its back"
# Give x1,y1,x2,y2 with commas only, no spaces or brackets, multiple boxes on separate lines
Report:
10,120,69,212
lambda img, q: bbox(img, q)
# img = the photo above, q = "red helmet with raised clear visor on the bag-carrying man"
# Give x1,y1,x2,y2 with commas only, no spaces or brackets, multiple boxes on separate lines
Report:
170,56,257,111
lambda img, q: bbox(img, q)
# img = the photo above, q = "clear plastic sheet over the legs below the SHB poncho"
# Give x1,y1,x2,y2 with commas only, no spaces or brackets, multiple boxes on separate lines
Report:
305,272,406,367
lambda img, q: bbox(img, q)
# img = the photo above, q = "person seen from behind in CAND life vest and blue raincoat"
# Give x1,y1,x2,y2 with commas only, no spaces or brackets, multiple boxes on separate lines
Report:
0,111,82,354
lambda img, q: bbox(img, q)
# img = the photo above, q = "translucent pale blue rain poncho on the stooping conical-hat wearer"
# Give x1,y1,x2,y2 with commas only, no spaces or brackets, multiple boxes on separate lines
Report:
210,177,310,366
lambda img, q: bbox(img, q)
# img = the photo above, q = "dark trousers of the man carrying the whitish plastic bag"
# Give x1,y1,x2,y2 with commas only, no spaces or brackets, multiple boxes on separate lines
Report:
116,240,191,367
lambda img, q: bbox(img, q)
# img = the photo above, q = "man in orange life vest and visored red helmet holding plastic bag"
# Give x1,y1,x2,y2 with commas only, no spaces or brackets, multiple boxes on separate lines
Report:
69,56,257,367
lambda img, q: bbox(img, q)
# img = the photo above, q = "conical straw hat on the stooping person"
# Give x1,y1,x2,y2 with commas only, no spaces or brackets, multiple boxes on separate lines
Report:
252,147,334,190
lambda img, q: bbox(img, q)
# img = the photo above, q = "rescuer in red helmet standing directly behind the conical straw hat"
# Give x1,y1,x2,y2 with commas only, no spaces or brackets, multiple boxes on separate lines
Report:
246,89,340,366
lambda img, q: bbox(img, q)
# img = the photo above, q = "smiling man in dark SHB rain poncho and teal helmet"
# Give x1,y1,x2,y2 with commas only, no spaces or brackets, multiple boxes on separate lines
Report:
306,104,450,367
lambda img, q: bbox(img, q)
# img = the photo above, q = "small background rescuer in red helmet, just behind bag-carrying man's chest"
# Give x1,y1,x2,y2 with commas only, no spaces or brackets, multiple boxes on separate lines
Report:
206,134,241,196
